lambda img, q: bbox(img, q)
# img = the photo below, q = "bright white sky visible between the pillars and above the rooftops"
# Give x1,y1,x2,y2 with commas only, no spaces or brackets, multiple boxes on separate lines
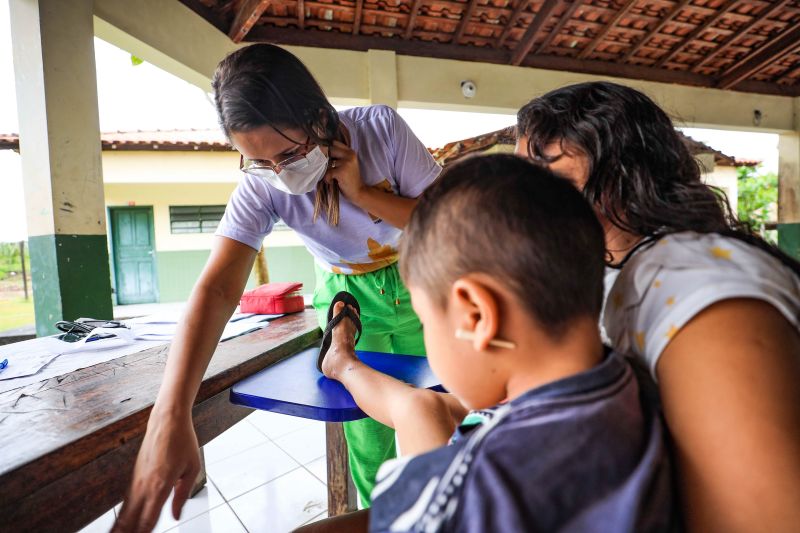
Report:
0,1,778,242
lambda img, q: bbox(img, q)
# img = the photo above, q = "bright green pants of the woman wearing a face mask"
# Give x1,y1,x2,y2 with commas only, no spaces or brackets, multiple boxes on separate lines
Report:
314,263,425,508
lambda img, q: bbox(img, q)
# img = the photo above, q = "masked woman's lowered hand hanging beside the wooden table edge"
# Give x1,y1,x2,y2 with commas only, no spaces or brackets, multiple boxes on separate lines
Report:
112,408,200,532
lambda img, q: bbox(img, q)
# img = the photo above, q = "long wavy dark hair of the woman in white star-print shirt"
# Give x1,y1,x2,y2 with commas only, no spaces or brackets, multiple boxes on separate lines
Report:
517,82,800,274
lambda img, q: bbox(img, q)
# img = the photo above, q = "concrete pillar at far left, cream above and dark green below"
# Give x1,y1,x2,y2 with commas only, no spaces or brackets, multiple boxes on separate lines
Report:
10,0,113,335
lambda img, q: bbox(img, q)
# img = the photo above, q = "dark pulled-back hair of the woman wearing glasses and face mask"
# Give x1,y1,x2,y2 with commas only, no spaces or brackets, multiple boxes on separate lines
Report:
211,43,339,225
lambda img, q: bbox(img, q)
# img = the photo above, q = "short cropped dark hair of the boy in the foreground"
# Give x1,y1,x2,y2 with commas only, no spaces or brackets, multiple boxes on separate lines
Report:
400,154,605,338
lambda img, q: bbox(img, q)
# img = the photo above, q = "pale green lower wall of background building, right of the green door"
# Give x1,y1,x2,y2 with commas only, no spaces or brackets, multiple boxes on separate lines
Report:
156,246,314,302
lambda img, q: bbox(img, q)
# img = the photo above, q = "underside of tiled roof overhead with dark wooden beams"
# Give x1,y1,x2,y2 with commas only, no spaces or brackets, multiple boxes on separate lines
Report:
181,0,800,96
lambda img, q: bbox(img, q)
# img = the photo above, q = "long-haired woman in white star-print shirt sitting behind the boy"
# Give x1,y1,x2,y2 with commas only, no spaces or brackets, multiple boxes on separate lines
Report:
516,82,800,532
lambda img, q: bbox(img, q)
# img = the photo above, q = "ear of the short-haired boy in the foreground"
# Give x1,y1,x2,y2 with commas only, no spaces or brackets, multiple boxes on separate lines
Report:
450,276,500,352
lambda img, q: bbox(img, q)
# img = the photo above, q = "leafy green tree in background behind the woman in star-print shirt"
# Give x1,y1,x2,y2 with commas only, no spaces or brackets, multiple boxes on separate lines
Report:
736,167,778,243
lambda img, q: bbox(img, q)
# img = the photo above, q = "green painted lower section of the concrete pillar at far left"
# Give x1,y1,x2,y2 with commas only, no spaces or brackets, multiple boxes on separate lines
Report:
28,235,114,336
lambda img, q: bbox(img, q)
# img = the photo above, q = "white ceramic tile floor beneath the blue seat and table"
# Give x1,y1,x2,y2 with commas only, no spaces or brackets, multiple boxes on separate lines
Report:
82,411,327,533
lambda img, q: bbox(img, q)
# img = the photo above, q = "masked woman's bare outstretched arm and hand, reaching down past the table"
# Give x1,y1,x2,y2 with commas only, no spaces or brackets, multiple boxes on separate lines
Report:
113,237,256,531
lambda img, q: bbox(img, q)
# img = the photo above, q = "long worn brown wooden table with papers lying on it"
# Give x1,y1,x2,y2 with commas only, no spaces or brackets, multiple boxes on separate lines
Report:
0,310,321,531
